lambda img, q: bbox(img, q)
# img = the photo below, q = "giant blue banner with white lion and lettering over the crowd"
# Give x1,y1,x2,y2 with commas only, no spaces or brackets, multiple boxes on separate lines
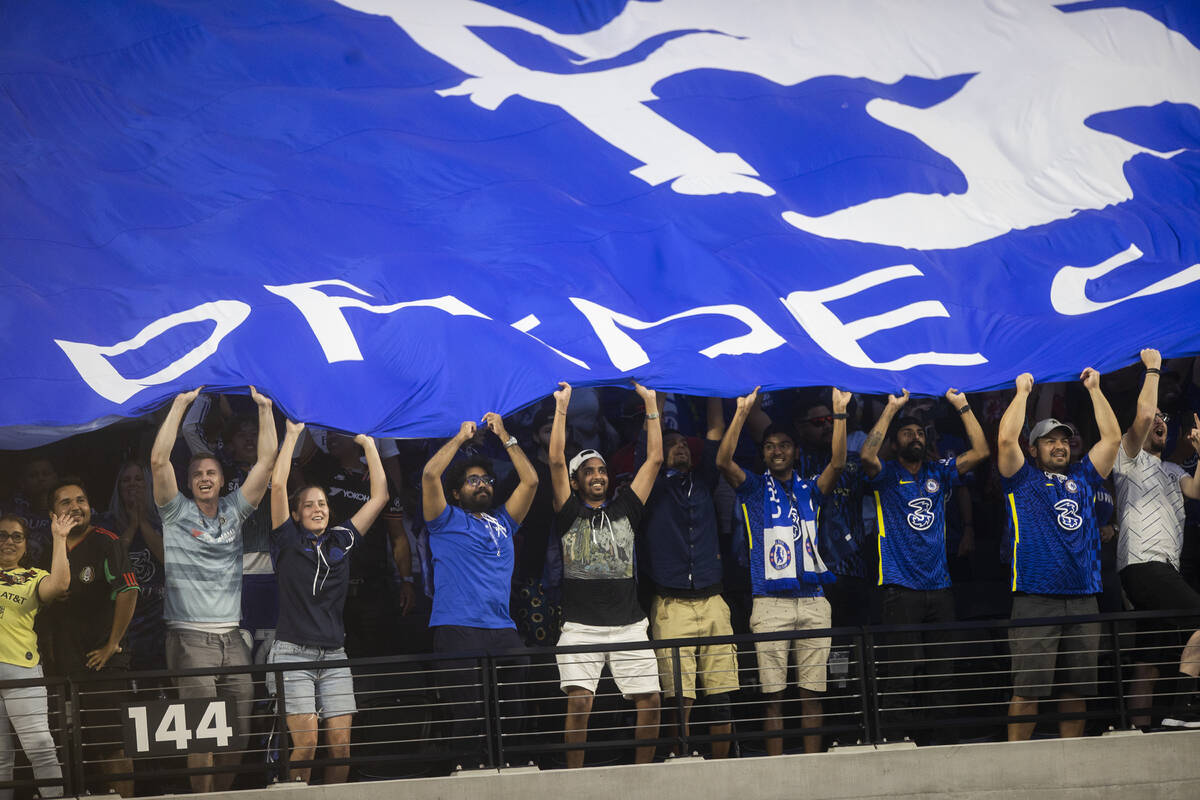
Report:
0,0,1200,444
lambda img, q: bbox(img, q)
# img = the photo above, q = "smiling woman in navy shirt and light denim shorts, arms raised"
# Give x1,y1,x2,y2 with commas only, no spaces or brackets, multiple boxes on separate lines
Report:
269,420,388,783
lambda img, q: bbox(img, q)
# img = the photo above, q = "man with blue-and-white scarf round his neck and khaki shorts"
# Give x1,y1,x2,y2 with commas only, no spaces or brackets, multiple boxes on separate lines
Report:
716,389,851,756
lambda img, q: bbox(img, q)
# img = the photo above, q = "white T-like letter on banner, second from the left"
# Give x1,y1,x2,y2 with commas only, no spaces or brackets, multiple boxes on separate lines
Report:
263,279,491,363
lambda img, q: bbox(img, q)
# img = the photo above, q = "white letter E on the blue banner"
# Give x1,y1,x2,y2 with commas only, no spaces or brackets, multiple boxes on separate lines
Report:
780,264,988,372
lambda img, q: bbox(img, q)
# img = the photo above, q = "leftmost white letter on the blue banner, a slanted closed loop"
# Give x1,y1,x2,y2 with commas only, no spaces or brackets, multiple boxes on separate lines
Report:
54,300,250,403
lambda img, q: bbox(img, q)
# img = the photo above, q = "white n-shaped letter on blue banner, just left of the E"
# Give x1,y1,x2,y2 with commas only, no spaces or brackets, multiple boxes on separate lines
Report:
570,297,786,372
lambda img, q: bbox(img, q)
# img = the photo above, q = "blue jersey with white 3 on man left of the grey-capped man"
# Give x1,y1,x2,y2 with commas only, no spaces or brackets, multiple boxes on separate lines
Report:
868,458,961,590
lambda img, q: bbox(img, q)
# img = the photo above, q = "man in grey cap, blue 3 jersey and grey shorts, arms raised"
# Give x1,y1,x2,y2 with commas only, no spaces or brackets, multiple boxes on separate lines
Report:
996,367,1121,741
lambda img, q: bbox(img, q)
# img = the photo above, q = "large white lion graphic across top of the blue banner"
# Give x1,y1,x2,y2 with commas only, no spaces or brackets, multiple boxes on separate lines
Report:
340,0,1200,249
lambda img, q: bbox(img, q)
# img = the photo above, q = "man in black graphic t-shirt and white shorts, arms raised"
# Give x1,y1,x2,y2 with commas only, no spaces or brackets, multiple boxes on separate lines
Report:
550,383,662,768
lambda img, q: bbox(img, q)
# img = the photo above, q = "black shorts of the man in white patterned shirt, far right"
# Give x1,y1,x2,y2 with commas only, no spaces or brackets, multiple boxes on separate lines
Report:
1121,561,1200,672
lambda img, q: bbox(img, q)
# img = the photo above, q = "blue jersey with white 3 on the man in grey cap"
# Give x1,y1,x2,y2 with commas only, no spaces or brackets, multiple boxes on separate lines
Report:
1003,456,1104,595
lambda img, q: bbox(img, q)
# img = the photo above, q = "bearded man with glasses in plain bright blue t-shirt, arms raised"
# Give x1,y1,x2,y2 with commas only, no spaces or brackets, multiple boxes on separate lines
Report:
421,413,538,758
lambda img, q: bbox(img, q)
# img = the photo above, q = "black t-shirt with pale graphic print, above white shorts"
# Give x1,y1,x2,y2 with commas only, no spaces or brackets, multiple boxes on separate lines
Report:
554,487,646,626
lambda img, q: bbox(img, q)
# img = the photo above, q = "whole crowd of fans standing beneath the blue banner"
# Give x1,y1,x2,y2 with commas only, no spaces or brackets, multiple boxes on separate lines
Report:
0,350,1200,796
